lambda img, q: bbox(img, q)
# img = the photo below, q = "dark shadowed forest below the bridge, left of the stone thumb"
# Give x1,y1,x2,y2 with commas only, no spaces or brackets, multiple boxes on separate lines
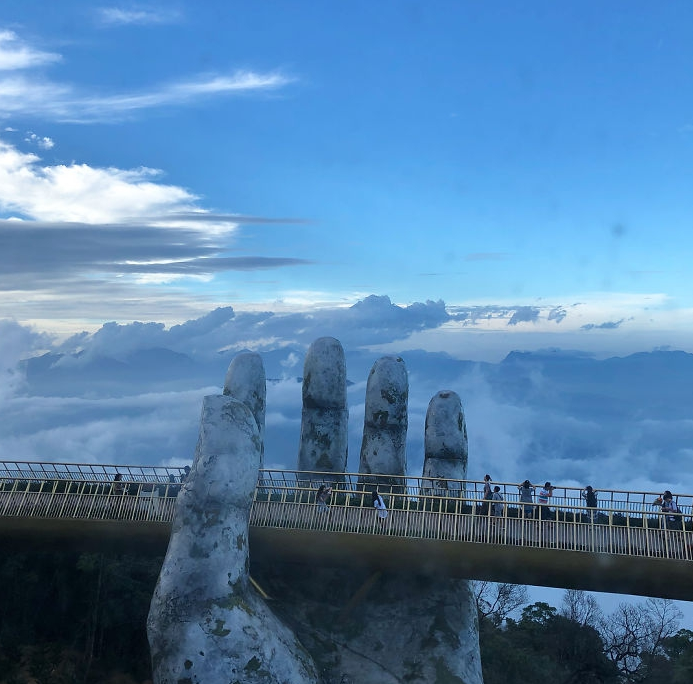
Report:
0,552,162,684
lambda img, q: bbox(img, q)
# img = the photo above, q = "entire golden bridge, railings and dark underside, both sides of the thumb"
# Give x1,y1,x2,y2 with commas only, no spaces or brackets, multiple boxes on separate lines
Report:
0,462,693,600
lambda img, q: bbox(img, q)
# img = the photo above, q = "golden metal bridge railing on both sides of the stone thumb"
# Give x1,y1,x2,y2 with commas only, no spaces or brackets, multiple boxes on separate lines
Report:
0,463,693,561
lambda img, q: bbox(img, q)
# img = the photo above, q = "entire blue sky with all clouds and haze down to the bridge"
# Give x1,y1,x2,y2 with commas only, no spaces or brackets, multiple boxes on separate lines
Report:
0,0,693,624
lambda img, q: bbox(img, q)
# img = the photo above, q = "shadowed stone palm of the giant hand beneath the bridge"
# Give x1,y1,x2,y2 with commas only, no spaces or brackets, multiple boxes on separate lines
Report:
253,564,483,684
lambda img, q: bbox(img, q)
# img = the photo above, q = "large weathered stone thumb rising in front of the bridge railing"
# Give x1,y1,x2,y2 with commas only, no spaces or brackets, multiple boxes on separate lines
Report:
147,396,318,684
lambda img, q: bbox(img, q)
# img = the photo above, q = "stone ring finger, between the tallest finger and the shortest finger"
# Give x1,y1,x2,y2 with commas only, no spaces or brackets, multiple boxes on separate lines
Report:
359,356,409,475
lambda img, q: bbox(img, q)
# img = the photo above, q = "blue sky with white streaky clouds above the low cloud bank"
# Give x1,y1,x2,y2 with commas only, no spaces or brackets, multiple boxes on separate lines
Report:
0,0,693,353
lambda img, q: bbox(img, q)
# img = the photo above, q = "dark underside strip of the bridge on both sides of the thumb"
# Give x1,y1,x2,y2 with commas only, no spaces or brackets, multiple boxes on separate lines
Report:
0,517,693,601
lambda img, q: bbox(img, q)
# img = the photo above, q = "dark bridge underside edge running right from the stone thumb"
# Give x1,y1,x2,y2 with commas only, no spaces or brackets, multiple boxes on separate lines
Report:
251,527,693,601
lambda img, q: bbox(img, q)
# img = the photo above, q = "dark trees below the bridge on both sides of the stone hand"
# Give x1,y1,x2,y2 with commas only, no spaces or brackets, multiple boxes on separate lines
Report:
0,560,693,684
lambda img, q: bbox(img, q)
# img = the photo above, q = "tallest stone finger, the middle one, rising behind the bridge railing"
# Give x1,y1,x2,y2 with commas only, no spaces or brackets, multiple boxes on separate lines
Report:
298,337,349,473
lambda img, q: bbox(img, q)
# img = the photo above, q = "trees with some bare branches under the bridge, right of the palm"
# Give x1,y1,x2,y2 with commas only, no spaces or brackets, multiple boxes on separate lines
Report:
479,587,693,684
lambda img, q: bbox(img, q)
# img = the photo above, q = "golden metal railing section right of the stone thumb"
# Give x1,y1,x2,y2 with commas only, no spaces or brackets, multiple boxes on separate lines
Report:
251,470,693,560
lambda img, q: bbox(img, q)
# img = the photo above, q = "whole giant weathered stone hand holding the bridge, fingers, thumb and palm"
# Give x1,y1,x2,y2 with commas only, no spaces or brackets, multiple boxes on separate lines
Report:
147,338,482,684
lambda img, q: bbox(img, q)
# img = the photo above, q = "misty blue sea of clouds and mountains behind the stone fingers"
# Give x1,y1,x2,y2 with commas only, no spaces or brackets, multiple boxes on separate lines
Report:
0,296,693,492
